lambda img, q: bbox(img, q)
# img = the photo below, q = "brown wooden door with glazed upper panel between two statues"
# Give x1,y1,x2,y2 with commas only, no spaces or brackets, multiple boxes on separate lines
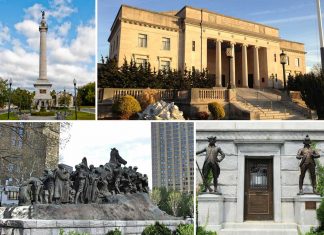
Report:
244,159,273,220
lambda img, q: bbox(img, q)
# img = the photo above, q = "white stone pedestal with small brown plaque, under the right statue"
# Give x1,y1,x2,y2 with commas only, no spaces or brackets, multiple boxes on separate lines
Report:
294,194,322,233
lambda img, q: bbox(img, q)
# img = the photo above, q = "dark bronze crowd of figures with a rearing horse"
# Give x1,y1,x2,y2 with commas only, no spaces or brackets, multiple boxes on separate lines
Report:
19,148,149,205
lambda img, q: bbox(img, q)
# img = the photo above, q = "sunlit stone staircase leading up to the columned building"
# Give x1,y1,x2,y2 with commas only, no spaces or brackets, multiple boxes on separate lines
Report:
234,88,307,120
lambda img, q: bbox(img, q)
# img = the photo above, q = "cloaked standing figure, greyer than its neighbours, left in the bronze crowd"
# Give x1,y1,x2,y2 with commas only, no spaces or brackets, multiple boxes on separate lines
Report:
54,164,70,204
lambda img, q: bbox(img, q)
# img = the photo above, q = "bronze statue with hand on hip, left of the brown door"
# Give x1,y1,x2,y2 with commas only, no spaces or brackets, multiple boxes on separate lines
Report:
196,137,225,193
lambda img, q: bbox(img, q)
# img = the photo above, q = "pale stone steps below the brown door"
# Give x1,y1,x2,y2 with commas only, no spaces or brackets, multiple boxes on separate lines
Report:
217,221,298,235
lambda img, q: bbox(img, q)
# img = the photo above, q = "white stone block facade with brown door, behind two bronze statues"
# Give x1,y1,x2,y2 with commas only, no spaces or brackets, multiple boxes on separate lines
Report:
196,122,324,235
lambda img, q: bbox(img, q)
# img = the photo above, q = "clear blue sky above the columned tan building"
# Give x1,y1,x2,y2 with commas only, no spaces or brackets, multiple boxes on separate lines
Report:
97,0,324,68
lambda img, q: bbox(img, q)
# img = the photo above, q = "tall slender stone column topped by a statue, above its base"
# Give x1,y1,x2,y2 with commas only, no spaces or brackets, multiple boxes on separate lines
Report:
39,15,48,80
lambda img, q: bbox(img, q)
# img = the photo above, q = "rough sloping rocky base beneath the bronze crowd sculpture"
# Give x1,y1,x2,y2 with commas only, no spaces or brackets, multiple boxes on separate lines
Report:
0,193,178,220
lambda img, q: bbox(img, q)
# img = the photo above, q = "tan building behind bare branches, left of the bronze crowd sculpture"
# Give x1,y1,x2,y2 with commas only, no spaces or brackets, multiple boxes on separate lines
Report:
0,122,60,186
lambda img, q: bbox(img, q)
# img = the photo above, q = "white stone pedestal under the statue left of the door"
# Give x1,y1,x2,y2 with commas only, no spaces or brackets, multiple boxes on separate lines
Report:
198,193,224,232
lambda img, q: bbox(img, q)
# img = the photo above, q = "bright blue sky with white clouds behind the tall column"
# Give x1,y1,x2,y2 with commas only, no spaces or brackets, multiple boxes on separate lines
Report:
0,0,96,91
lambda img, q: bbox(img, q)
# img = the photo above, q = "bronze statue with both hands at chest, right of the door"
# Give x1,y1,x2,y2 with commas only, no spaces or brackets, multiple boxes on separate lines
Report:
296,135,320,195
